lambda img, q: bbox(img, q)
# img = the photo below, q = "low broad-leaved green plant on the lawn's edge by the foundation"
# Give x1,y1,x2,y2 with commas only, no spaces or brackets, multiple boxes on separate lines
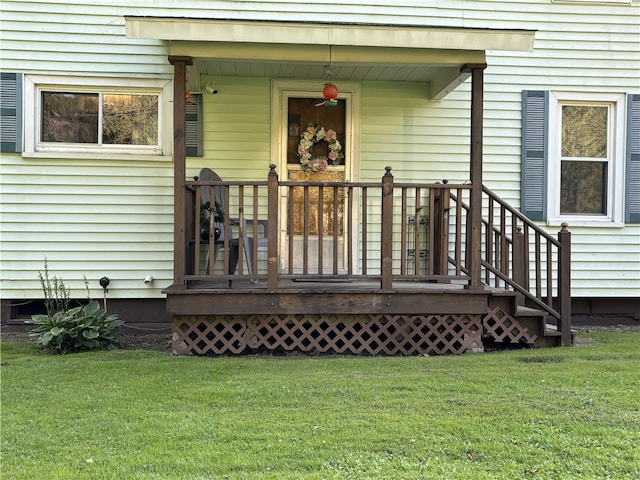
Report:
26,300,124,354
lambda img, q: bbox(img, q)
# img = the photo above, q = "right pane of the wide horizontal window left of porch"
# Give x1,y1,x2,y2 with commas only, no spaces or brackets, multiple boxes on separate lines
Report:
102,94,158,145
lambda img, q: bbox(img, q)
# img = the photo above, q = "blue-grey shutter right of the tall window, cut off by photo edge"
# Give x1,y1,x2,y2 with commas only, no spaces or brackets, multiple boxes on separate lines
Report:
625,94,640,223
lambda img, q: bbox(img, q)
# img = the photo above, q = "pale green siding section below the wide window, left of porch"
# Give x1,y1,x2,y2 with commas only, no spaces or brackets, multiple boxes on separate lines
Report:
0,157,173,298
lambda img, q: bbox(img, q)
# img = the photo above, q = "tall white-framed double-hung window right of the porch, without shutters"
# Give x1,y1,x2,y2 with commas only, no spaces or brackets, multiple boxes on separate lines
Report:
547,92,624,225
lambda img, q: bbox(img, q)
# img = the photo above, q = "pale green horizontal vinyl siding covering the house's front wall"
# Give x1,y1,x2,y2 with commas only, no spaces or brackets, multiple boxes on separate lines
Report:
0,0,640,299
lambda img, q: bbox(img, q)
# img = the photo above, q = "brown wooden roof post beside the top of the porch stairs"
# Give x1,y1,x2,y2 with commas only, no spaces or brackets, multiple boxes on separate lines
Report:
462,63,487,289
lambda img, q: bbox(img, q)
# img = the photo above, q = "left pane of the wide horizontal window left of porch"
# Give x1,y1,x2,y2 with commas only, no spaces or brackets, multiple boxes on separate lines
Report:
41,92,99,143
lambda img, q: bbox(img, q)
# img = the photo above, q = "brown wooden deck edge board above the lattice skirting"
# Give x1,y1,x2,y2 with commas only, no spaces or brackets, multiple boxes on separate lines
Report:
165,280,490,315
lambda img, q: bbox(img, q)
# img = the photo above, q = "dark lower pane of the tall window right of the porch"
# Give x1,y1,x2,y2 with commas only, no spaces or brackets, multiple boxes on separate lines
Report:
560,161,607,214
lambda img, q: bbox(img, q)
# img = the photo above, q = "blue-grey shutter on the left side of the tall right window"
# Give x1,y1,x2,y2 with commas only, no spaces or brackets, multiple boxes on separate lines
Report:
520,90,549,220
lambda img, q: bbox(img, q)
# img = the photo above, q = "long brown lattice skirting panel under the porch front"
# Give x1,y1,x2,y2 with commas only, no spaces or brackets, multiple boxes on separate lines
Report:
172,314,482,355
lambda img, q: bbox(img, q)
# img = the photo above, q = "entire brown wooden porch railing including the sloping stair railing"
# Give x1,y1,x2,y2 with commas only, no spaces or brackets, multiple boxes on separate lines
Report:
176,165,571,344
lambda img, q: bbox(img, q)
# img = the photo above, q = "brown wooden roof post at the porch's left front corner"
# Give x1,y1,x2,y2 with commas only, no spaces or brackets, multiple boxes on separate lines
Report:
169,56,193,287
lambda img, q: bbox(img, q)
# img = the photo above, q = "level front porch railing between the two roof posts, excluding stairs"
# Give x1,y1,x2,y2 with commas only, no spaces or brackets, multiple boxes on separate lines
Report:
182,167,469,290
